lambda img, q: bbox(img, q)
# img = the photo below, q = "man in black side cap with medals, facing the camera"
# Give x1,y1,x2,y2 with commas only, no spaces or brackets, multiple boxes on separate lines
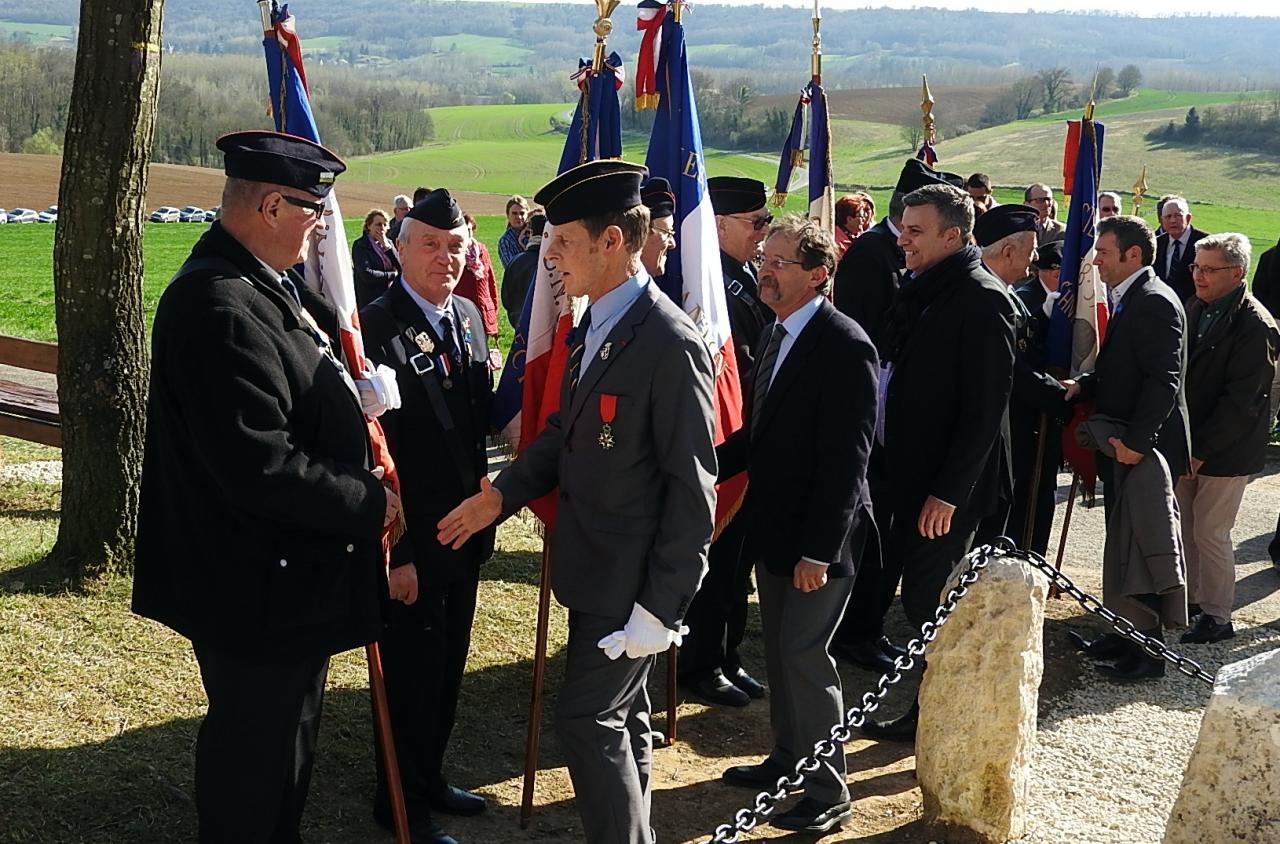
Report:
360,188,494,844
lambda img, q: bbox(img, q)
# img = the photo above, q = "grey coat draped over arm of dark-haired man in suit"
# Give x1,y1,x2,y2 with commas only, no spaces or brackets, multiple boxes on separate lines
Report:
1075,414,1187,630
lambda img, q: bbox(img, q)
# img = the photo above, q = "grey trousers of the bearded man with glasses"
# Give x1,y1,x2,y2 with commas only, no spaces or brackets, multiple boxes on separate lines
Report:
755,565,854,803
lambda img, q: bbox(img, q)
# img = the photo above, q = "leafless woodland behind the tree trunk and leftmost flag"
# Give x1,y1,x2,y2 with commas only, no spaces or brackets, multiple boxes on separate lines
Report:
0,44,433,165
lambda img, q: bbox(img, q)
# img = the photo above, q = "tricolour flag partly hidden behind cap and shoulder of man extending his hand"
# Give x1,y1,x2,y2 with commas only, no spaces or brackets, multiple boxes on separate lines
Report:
493,53,623,528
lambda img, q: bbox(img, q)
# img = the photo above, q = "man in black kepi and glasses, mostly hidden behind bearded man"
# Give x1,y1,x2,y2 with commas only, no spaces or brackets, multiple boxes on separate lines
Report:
678,175,773,707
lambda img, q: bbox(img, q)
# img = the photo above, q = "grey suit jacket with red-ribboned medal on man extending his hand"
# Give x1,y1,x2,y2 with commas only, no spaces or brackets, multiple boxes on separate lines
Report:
494,280,716,629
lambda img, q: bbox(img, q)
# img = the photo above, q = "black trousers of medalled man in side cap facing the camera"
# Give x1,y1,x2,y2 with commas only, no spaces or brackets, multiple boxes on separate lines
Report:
374,574,480,821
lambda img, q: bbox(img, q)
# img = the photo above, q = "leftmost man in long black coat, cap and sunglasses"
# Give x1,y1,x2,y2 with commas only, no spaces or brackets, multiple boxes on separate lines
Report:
133,132,401,844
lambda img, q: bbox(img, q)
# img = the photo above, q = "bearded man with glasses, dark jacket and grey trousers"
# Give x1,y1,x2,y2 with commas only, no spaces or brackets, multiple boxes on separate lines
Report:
717,216,878,832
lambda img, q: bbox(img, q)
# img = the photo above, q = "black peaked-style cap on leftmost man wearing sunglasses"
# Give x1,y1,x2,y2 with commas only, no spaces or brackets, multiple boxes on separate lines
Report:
218,131,347,199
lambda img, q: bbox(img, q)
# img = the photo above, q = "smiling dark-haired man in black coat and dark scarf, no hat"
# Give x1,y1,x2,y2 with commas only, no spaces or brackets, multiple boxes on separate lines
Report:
863,184,1016,740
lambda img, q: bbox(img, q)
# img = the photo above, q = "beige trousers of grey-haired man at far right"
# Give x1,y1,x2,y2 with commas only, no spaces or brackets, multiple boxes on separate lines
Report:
1174,475,1249,624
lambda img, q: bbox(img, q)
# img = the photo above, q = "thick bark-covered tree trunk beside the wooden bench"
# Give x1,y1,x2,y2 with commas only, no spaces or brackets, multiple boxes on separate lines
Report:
51,0,164,579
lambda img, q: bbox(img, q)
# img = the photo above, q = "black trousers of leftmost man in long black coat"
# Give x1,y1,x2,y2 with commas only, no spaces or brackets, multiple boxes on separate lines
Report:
193,643,329,844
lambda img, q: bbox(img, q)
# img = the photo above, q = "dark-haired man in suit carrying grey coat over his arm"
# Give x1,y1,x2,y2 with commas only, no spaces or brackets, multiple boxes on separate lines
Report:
1068,215,1190,680
